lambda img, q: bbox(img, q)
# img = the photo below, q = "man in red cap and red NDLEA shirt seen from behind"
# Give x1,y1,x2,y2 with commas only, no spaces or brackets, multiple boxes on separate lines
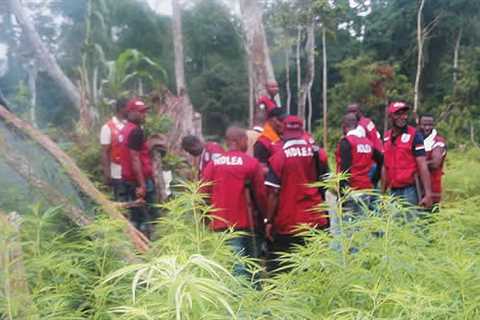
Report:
265,116,328,271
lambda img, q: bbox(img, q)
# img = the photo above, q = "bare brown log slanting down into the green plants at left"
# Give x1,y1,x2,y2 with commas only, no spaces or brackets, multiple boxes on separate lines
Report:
0,105,149,252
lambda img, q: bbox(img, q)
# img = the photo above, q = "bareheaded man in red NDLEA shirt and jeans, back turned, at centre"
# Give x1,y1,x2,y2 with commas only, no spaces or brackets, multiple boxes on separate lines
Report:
203,127,267,276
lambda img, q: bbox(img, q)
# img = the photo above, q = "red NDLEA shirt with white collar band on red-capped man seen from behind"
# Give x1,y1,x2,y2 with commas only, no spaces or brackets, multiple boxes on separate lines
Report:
265,139,328,235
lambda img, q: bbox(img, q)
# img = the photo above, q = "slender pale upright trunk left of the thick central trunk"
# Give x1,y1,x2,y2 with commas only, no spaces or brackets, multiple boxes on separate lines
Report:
172,0,197,137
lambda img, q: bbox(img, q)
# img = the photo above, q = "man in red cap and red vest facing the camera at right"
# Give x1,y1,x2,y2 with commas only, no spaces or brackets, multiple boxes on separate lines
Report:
382,102,432,209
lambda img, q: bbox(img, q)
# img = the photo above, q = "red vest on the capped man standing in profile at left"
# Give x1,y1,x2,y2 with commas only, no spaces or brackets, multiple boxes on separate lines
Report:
120,122,153,182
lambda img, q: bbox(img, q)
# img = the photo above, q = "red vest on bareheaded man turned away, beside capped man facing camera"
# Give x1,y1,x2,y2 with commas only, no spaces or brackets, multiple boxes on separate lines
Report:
335,135,374,190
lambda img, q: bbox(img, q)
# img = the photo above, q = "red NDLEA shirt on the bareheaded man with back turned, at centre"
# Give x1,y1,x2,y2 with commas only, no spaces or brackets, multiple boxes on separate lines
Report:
203,151,267,230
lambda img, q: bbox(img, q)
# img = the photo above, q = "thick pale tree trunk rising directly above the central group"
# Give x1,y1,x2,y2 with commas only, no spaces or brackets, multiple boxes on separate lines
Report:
240,0,275,123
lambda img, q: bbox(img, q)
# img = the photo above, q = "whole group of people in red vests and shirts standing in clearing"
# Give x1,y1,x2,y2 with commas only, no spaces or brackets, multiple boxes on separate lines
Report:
101,83,446,275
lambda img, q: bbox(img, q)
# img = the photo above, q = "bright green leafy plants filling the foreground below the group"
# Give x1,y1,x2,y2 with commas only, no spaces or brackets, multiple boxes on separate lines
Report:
0,150,480,320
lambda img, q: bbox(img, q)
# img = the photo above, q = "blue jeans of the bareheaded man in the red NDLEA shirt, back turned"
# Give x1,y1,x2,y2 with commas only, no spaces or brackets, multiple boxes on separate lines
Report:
228,234,261,280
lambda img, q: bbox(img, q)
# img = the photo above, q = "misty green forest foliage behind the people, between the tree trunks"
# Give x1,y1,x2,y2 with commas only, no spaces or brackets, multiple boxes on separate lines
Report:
0,0,480,144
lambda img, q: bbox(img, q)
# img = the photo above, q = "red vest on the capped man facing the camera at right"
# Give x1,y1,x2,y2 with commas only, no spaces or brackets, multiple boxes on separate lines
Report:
383,126,417,188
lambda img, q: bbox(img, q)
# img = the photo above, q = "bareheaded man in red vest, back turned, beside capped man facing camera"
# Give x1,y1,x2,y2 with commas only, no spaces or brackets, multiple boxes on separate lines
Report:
335,113,383,218
